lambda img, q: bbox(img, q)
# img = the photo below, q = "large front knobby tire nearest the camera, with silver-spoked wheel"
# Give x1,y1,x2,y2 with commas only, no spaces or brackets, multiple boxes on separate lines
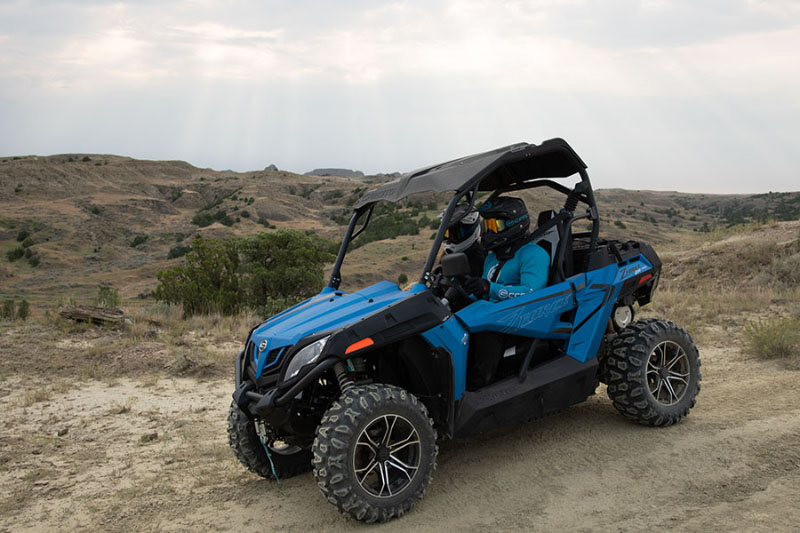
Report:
311,384,438,522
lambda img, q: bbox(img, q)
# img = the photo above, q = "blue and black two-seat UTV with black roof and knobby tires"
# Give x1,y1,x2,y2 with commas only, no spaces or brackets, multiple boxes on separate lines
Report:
228,139,700,522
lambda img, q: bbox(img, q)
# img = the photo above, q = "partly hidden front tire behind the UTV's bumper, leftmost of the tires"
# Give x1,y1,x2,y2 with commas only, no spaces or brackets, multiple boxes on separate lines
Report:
228,402,311,479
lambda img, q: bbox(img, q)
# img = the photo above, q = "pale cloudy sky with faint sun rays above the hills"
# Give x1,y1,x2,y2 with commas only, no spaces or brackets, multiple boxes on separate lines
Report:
0,0,800,193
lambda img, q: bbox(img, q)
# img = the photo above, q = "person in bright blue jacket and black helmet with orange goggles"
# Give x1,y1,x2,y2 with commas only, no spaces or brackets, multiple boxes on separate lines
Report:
464,196,550,302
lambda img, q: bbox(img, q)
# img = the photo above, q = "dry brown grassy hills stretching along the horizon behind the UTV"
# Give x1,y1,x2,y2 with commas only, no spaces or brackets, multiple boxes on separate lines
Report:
0,154,800,302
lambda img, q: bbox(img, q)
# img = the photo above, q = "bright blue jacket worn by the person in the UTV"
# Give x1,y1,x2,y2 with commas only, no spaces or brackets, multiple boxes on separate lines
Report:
483,242,550,302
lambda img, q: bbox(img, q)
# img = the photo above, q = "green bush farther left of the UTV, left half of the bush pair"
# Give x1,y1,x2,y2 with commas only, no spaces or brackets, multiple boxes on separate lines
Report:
154,237,240,315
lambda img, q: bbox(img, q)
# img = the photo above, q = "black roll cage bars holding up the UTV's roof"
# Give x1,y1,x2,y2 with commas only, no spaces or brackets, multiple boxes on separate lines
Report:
328,168,600,290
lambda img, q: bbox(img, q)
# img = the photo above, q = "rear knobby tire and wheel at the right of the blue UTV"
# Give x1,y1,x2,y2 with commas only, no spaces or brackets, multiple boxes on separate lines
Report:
603,319,701,426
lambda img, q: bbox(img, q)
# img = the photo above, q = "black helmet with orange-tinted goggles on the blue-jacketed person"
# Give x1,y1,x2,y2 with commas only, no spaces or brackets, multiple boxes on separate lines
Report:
478,196,531,255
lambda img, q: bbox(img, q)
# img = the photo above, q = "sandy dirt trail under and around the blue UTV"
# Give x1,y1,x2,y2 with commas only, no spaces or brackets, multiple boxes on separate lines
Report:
0,340,800,532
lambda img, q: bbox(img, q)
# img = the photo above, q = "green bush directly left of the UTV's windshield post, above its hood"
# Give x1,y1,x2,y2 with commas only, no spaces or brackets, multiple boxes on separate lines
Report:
239,230,335,308
